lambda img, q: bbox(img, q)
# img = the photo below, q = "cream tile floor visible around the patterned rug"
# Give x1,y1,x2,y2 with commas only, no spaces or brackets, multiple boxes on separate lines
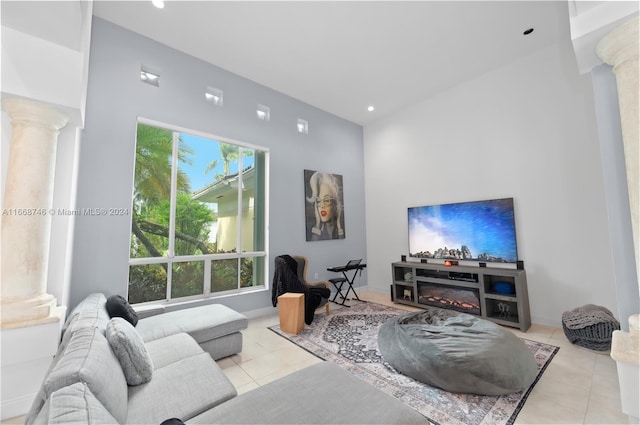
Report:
2,292,628,424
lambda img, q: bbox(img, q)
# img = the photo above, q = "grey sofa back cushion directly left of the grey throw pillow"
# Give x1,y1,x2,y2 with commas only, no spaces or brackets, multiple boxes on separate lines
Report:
43,328,127,423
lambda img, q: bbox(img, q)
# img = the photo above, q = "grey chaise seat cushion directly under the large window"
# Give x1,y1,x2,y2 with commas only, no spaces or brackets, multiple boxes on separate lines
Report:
136,304,248,343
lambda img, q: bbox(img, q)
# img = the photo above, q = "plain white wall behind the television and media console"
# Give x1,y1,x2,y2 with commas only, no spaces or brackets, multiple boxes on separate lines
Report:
364,42,617,326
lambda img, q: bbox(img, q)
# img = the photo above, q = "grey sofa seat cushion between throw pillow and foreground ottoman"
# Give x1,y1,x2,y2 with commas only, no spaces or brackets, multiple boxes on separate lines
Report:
127,353,237,424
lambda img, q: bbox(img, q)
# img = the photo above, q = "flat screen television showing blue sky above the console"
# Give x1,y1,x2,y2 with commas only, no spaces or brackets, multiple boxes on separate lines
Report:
408,198,518,263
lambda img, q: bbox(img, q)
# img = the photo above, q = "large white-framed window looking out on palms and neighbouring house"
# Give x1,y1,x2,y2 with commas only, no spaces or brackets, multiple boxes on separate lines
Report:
129,122,268,304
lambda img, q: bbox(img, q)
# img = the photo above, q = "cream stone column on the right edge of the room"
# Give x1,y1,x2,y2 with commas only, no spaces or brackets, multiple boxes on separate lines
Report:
596,17,640,285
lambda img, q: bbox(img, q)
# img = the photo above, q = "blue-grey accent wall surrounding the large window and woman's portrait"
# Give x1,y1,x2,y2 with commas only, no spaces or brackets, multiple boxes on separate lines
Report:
69,17,367,311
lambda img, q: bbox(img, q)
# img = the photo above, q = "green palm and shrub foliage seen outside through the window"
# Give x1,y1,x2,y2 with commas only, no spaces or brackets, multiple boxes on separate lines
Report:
129,124,254,304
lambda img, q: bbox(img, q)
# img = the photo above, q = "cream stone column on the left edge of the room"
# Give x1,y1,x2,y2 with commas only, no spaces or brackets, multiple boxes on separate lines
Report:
0,98,68,328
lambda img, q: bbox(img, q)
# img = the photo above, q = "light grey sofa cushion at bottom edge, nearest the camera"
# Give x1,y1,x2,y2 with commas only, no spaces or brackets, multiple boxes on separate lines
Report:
33,382,118,425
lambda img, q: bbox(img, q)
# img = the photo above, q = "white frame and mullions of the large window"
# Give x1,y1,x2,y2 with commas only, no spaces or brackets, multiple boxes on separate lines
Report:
127,117,270,306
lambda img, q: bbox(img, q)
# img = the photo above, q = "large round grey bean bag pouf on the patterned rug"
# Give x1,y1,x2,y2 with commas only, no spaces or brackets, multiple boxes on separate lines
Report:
378,308,538,395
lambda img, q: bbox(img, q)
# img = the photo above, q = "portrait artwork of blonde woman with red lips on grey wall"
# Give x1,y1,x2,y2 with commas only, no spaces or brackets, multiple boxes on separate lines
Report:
304,170,344,241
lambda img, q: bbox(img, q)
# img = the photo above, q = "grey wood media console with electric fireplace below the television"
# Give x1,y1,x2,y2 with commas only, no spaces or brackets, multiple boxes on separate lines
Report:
391,262,531,331
